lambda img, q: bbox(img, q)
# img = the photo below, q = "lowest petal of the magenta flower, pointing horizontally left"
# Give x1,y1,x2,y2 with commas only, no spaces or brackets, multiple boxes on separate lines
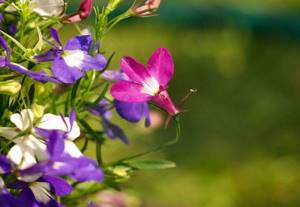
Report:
110,81,152,102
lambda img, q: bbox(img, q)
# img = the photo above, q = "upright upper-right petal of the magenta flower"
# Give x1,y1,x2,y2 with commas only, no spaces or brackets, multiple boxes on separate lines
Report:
148,48,174,87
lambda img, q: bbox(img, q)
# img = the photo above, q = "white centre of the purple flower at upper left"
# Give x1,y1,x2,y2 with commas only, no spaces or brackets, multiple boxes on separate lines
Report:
63,50,85,68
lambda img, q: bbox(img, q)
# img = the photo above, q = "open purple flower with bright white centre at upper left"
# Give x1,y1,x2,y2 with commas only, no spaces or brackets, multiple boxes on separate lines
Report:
35,28,107,84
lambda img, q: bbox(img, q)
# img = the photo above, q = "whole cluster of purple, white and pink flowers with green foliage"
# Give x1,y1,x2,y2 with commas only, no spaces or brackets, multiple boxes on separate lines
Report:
0,0,188,207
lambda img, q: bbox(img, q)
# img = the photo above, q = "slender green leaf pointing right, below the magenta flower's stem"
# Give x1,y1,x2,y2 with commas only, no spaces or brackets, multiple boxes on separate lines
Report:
125,160,176,170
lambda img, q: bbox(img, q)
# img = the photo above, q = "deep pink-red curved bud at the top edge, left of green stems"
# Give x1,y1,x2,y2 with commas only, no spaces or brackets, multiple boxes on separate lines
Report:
62,0,94,23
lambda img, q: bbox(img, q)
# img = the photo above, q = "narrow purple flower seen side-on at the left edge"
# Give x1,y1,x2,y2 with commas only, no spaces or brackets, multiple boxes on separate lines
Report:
0,36,59,83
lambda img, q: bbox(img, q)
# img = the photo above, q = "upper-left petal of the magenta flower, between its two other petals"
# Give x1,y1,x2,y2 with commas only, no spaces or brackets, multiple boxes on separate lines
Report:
121,57,150,83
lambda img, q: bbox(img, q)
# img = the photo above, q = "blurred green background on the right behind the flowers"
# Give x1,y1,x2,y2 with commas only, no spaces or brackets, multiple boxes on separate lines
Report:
71,0,300,207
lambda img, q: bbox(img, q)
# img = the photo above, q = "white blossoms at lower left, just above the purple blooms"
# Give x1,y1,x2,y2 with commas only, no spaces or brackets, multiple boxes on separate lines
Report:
0,109,82,169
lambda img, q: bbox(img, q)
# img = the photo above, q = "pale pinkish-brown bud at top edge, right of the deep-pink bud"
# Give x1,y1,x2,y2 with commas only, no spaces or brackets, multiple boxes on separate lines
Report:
132,0,161,17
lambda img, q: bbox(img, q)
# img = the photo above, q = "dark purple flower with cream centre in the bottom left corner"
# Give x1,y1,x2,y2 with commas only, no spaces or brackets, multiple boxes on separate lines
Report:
0,153,72,207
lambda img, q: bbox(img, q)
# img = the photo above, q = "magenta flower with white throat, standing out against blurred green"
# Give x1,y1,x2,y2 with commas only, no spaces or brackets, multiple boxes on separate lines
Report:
111,48,180,116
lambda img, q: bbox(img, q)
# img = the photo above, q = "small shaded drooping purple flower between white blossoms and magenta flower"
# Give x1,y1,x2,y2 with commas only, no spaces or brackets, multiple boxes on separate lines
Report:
90,99,128,144
